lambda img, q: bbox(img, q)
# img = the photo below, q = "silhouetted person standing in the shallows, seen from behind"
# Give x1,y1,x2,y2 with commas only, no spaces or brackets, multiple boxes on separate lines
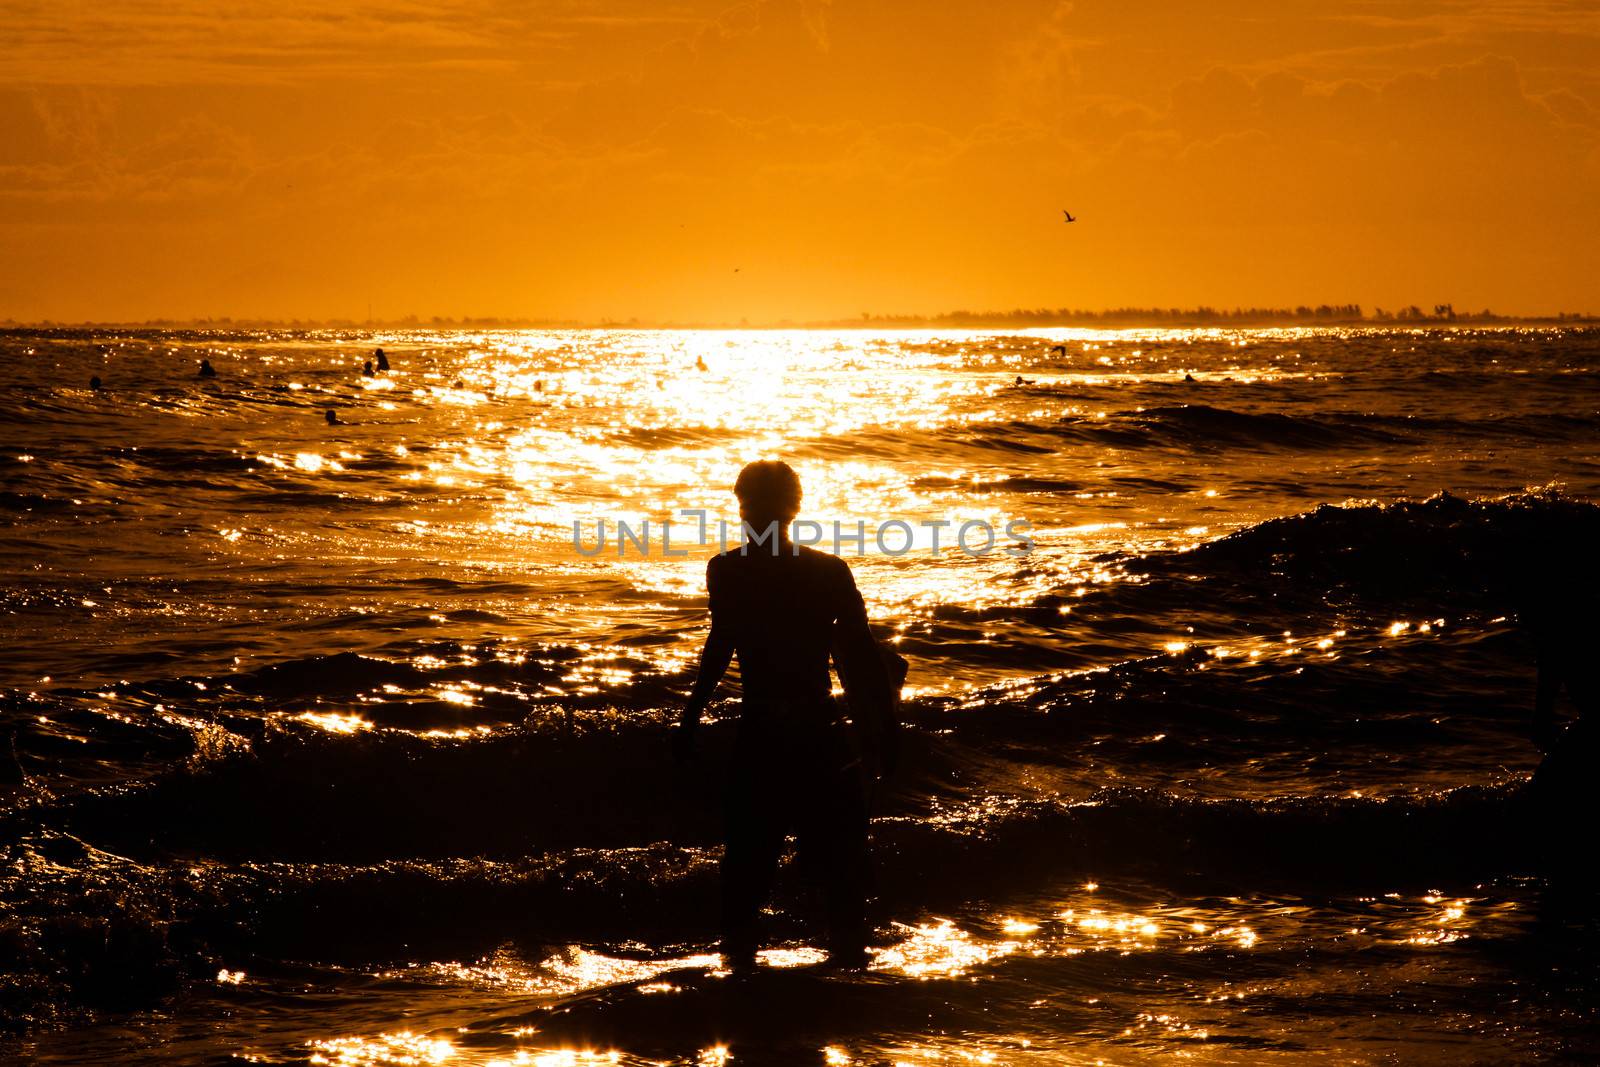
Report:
674,461,896,968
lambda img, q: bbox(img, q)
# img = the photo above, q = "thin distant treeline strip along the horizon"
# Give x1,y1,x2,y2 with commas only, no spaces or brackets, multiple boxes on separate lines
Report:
0,304,1600,331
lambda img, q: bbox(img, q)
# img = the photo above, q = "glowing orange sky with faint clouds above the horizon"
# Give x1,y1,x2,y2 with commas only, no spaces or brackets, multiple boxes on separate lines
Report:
0,0,1600,323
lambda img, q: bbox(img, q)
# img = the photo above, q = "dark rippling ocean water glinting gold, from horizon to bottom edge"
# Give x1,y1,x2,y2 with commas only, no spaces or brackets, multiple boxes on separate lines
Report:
0,328,1600,1065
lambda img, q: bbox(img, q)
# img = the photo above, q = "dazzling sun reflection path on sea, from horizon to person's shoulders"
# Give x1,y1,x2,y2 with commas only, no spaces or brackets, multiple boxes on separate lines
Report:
243,330,1338,704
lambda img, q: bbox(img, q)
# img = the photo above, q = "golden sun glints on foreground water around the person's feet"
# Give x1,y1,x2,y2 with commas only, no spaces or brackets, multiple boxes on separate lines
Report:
281,881,1515,1067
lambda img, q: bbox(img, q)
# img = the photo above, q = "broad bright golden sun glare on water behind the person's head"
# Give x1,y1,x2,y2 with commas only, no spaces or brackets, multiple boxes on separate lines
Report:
222,330,1273,703
